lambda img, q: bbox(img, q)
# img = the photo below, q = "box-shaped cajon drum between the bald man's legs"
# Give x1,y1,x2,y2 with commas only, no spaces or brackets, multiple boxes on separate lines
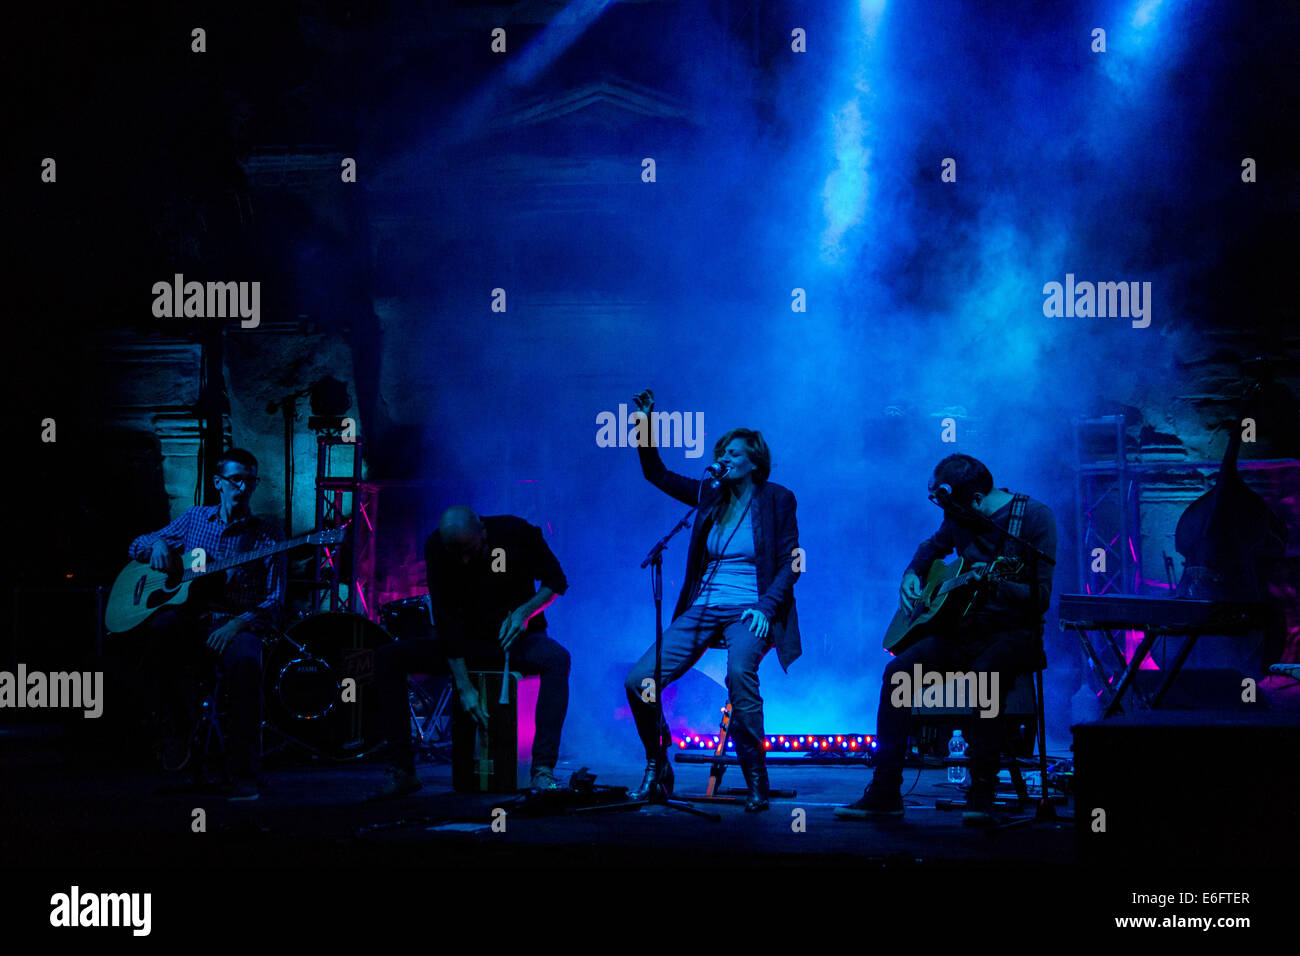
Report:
451,670,536,793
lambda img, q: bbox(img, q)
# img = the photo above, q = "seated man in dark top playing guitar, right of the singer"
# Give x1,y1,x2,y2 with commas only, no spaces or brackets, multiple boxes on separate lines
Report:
835,455,1057,826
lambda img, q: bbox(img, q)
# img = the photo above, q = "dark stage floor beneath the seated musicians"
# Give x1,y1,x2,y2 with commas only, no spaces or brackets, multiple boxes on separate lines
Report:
0,735,1074,868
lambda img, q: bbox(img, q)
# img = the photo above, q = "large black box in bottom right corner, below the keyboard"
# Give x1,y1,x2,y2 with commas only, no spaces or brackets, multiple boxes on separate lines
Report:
1073,710,1300,866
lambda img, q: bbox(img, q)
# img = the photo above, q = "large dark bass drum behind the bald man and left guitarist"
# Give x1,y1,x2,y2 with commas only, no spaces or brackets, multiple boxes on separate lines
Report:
264,611,393,760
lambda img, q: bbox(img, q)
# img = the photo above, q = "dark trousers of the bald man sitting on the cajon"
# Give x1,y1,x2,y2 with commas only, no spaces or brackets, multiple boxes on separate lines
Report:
374,631,569,773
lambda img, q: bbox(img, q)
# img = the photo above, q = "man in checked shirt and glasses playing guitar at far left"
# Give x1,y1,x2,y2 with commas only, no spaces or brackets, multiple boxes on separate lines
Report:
130,449,285,800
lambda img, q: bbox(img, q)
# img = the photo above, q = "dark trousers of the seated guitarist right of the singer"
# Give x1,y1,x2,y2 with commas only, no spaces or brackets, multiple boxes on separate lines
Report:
872,626,1043,788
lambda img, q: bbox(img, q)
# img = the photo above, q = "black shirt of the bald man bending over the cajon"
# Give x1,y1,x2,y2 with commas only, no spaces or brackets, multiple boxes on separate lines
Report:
424,515,568,658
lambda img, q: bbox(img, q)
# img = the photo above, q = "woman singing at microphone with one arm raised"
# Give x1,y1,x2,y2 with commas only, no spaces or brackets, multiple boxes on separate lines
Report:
625,389,803,812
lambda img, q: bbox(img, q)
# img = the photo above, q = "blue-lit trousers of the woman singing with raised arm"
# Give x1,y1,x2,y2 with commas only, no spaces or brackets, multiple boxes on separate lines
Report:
624,605,772,766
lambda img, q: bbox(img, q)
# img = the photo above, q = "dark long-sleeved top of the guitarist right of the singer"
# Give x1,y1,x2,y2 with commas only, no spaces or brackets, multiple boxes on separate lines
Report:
907,488,1056,631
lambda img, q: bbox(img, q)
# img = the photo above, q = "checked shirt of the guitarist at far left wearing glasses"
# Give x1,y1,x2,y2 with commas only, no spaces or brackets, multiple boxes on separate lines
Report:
130,505,285,627
